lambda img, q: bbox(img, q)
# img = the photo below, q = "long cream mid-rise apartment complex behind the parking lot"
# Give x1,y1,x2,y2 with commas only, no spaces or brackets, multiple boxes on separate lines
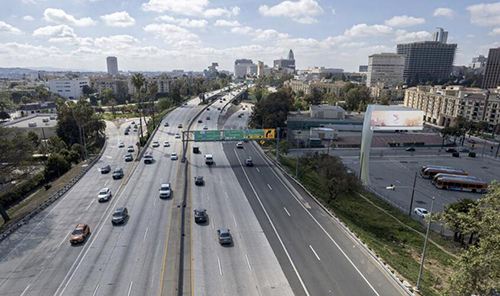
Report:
404,86,500,127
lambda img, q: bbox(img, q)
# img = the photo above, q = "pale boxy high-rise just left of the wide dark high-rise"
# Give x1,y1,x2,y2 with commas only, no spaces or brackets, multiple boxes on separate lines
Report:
366,53,405,87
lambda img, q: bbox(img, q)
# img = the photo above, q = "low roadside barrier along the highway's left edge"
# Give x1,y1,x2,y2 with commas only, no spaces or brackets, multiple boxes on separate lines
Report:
0,138,108,243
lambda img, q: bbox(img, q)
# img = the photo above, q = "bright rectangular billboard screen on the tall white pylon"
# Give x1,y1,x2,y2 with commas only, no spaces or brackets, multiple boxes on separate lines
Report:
370,110,424,131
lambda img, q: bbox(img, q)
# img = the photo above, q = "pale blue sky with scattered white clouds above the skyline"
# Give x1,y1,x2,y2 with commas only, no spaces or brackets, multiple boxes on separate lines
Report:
0,0,500,71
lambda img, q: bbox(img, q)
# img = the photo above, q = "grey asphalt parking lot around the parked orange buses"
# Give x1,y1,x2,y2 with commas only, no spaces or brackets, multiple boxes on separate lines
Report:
342,153,500,219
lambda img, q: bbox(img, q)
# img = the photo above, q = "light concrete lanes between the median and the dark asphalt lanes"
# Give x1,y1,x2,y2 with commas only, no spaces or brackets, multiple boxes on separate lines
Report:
188,96,293,295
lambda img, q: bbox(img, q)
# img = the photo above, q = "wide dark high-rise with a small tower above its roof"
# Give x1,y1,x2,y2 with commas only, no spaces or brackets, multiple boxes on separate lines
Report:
397,28,457,82
